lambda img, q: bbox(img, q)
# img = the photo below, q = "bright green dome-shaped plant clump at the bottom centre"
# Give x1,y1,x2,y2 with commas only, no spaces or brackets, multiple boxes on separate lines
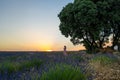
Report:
40,64,86,80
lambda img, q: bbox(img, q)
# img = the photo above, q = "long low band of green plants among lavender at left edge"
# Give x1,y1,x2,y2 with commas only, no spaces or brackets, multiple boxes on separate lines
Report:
0,59,42,74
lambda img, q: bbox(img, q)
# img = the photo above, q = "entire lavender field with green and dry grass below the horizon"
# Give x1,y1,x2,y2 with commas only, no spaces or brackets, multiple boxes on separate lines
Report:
0,52,120,80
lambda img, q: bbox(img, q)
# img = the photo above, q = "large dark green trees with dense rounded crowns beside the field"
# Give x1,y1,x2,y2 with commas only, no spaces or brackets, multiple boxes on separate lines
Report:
58,0,120,53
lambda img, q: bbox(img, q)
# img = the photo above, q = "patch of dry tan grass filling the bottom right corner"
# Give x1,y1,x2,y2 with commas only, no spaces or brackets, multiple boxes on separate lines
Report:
89,55,120,80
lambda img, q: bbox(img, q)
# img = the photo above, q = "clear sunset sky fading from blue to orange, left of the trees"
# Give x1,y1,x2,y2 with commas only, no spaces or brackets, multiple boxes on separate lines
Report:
0,0,83,51
